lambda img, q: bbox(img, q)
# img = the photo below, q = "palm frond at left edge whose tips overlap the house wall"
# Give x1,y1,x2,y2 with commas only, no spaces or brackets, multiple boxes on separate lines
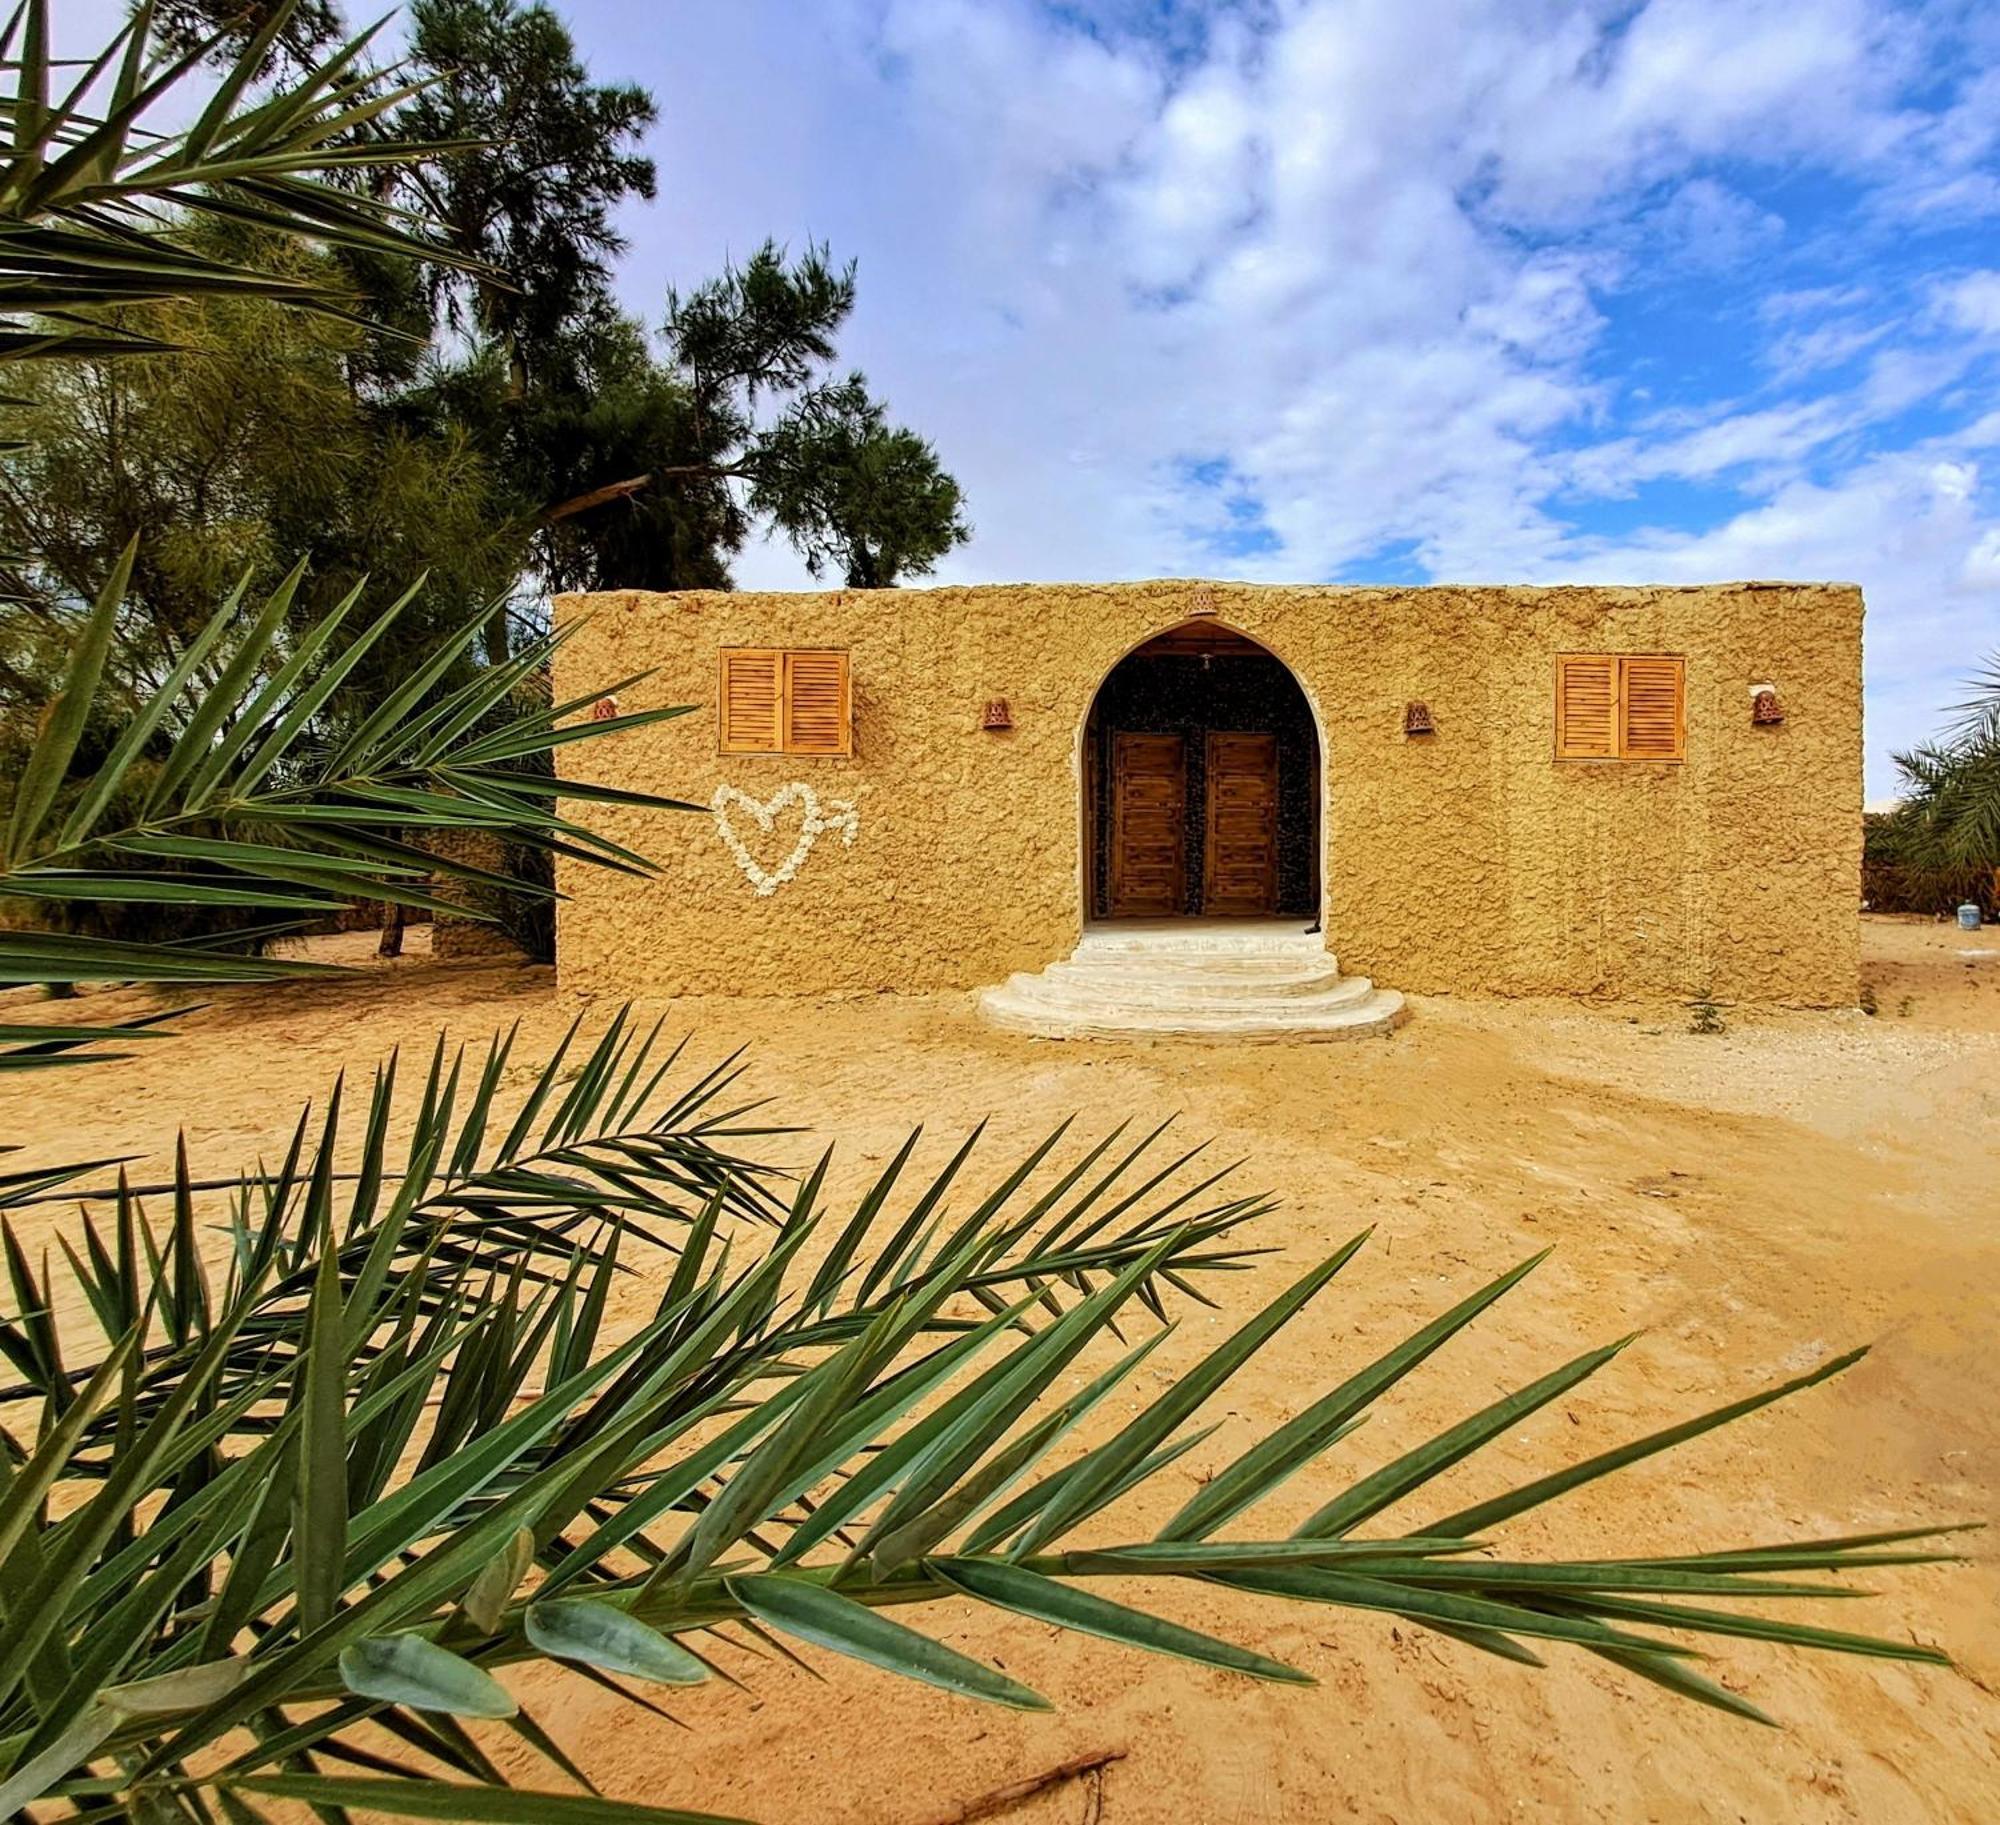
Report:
0,546,684,1069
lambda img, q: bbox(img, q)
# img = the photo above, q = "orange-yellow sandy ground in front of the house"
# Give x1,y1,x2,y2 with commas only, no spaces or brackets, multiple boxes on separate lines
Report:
0,919,2000,1825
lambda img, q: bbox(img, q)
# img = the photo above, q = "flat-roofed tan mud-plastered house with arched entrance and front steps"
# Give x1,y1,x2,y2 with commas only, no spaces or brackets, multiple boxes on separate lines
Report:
556,582,1862,1035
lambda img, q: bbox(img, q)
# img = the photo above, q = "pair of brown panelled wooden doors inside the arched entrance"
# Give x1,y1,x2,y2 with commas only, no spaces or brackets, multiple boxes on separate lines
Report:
1108,728,1278,919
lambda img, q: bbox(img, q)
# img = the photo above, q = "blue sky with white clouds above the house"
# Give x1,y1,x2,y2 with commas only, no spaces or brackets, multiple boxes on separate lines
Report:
70,0,2000,798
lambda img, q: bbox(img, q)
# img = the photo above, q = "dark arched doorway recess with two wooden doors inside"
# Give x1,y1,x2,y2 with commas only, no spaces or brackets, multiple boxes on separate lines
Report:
1084,620,1320,919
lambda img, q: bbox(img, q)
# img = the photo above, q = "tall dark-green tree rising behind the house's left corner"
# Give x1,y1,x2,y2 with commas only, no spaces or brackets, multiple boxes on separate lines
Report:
370,0,966,600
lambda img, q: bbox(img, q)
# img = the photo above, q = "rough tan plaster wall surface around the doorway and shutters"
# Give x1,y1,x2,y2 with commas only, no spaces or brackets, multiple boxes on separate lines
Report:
556,582,1862,1005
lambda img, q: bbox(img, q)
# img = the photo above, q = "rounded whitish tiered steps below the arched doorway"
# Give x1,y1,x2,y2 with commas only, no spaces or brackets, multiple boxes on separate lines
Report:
978,919,1406,1041
